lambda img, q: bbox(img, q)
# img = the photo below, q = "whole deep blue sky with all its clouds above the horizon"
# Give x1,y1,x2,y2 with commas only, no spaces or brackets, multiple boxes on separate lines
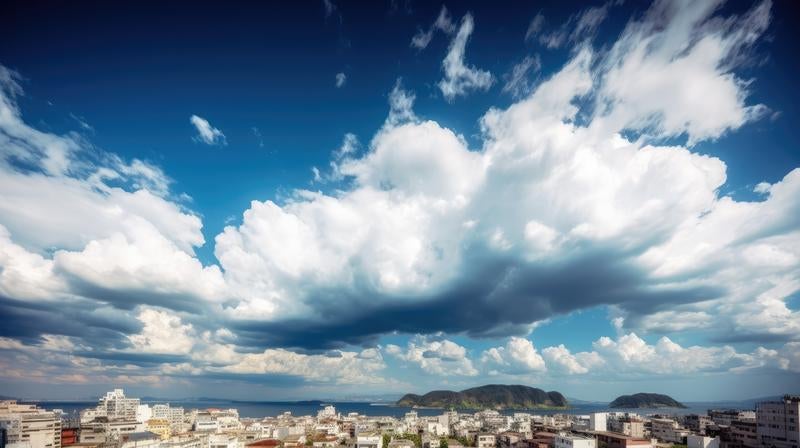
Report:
0,0,800,401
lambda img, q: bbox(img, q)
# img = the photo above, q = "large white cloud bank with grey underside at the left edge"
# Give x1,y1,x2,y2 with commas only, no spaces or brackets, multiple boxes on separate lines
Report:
0,66,225,351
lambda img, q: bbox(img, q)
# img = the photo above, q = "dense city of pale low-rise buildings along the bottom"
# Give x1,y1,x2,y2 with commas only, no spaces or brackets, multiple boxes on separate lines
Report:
0,389,800,448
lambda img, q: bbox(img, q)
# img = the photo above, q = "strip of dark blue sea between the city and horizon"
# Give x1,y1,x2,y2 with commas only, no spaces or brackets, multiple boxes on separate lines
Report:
25,400,752,418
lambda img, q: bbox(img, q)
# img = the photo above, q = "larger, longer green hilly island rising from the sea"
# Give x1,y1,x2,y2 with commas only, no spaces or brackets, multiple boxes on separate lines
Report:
396,384,569,409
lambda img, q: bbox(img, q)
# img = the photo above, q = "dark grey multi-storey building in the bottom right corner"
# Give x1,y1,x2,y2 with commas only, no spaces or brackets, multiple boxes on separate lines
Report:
756,395,800,448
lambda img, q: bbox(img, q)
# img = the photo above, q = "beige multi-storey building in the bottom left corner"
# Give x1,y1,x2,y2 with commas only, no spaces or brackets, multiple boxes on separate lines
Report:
0,400,61,448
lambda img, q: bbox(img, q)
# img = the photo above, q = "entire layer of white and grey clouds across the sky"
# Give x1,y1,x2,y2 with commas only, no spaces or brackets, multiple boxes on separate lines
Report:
0,1,800,392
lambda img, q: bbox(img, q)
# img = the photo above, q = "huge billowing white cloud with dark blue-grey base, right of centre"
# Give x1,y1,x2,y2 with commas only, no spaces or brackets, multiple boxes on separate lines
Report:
206,2,800,347
